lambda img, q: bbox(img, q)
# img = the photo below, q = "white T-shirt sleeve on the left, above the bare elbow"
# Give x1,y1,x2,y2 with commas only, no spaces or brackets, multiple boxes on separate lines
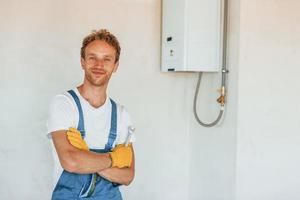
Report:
47,94,78,138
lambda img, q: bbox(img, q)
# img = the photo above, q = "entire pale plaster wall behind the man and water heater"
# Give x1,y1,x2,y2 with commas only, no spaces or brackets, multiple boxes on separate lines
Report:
0,0,300,200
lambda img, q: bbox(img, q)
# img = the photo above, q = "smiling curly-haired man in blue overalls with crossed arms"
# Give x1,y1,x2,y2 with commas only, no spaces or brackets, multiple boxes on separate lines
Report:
47,29,134,200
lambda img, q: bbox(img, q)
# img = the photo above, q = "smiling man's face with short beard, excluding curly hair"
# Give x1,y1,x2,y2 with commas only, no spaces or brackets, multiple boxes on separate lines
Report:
81,40,119,86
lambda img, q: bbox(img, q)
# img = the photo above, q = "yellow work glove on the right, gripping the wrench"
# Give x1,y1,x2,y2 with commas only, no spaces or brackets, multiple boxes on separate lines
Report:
109,144,132,168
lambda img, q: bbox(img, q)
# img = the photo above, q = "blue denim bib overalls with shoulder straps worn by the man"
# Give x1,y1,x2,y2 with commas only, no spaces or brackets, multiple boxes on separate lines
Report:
52,90,122,200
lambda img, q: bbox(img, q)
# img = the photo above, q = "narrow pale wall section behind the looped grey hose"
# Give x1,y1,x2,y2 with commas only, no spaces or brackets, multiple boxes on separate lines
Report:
189,0,240,200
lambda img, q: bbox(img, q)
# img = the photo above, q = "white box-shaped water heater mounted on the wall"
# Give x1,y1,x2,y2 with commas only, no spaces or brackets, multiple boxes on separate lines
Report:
161,0,224,72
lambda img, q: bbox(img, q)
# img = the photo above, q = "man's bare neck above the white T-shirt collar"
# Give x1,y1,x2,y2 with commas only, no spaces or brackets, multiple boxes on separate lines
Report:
77,83,107,108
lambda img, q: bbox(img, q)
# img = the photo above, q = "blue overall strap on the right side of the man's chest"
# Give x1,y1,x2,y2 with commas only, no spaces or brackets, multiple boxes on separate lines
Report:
105,99,117,151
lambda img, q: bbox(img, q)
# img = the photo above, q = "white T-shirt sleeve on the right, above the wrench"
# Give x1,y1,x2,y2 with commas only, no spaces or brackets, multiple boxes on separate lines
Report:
116,106,135,144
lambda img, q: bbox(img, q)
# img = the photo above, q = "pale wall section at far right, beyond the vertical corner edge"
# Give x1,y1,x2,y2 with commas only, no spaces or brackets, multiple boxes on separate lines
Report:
237,0,300,200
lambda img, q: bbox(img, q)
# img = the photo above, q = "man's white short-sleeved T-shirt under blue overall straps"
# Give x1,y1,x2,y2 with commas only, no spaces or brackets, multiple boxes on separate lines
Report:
47,88,135,187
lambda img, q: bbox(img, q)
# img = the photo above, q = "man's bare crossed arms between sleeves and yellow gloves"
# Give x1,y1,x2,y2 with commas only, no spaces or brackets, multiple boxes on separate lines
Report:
52,130,135,185
